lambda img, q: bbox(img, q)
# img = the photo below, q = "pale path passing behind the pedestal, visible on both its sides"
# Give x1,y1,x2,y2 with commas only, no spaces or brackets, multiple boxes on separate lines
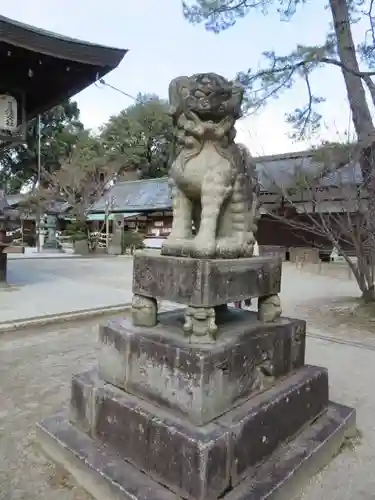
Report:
0,257,358,322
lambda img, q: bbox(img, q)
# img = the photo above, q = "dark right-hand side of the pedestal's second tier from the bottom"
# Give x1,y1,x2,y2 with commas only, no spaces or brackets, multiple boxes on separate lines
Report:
215,366,328,486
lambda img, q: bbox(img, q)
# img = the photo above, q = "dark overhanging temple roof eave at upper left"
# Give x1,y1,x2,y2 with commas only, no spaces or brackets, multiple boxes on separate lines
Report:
0,16,127,270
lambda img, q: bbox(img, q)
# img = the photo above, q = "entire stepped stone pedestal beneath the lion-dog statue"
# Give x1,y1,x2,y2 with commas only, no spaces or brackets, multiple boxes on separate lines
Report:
38,253,355,500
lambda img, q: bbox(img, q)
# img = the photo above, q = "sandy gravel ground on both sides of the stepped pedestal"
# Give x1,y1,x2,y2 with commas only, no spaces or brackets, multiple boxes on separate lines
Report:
0,266,375,500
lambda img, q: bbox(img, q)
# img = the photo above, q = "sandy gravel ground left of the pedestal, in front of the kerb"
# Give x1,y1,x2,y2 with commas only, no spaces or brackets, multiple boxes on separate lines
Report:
0,324,97,500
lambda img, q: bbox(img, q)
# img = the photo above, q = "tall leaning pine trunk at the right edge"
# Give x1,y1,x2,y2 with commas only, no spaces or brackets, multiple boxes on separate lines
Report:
330,0,375,300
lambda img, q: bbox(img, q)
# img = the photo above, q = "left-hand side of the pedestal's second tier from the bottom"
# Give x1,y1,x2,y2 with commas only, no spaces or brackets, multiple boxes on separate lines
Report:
72,373,231,500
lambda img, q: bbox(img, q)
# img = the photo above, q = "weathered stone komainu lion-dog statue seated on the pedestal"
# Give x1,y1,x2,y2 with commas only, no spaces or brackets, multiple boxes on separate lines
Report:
162,73,259,258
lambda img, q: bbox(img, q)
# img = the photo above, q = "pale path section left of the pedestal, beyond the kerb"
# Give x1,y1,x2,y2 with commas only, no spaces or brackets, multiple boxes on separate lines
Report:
0,257,133,322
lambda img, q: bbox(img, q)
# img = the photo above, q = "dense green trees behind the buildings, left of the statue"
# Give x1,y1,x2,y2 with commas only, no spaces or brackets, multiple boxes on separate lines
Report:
0,95,173,194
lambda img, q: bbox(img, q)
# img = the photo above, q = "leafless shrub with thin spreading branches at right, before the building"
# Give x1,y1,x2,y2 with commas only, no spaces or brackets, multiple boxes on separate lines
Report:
262,143,375,297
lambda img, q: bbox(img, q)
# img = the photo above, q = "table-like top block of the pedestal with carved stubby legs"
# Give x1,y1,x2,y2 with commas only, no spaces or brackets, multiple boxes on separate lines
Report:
133,252,281,343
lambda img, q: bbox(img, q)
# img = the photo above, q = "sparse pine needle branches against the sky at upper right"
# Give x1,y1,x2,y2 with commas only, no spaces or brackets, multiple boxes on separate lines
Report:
182,0,375,139
